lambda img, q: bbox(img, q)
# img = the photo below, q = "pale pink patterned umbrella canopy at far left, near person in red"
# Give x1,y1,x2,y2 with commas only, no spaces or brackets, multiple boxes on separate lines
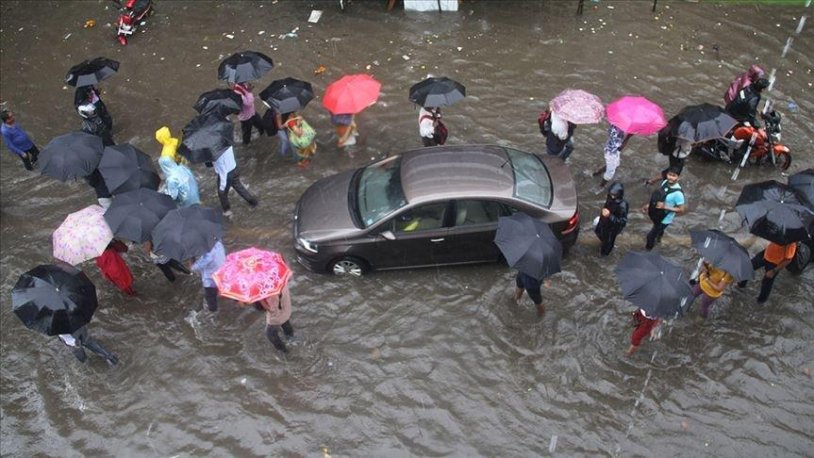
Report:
51,205,113,265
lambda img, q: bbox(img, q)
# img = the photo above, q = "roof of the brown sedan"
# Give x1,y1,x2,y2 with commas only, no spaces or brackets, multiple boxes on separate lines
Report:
401,145,514,204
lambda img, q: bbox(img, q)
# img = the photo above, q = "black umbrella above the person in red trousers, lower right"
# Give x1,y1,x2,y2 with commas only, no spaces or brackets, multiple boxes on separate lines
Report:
616,251,692,318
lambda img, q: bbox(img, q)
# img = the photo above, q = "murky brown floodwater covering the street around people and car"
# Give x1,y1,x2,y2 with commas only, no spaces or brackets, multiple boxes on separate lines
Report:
0,0,814,456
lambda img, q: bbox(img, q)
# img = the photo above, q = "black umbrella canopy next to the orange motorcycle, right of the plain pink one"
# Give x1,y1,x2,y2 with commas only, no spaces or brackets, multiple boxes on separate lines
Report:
668,103,738,143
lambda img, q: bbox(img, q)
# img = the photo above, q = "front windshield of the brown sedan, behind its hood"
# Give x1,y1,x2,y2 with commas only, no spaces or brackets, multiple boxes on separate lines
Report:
356,156,407,228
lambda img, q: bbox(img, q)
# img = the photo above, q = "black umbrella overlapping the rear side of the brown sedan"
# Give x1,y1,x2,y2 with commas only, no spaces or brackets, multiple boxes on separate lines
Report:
495,212,562,280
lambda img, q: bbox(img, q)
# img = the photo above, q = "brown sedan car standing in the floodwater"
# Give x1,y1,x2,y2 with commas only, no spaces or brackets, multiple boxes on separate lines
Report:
294,145,579,275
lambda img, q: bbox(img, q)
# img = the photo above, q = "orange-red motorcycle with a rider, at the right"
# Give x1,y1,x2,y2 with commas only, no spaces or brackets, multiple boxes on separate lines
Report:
693,110,791,170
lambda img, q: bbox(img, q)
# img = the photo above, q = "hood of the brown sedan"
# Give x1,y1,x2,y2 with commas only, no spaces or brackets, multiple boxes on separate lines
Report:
294,170,360,242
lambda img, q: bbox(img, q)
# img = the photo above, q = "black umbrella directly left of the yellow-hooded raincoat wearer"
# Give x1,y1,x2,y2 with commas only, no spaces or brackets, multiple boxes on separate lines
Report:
99,143,161,194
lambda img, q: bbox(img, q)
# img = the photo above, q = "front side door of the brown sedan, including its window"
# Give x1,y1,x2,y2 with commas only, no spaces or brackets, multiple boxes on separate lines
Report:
364,201,451,269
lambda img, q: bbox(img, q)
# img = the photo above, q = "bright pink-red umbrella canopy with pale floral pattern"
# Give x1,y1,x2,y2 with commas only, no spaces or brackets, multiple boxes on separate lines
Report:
212,248,291,303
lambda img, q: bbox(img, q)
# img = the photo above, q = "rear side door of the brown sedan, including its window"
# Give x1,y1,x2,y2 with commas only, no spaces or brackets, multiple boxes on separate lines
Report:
436,199,506,264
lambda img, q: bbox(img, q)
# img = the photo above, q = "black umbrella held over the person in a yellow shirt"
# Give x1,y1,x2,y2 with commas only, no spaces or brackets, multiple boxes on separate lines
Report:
690,229,754,281
